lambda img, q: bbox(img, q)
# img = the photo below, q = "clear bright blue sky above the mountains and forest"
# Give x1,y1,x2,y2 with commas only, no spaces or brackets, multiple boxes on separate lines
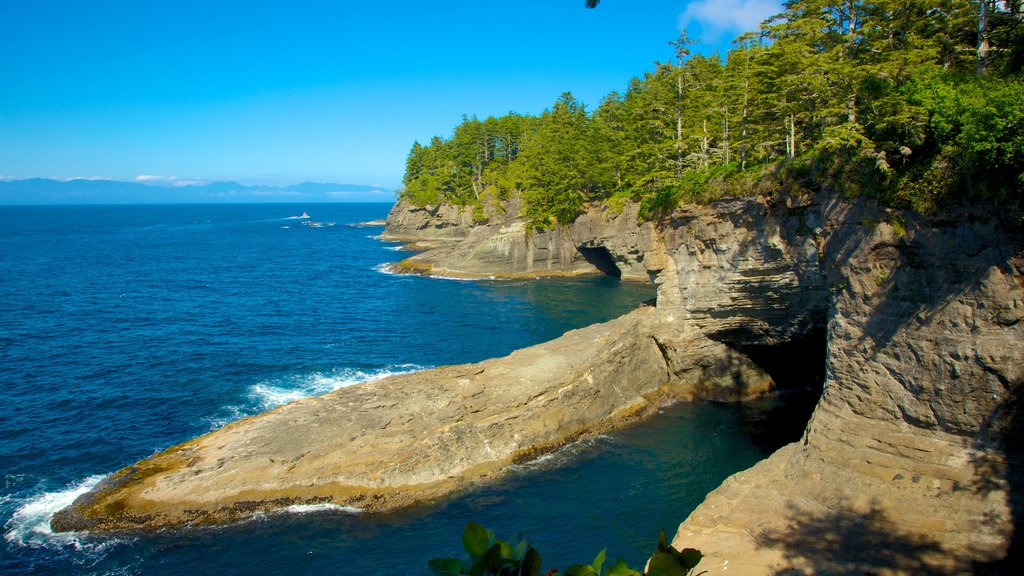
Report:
0,0,780,188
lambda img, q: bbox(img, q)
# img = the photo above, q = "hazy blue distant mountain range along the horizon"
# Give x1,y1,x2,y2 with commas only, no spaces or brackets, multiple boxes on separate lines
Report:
0,178,394,205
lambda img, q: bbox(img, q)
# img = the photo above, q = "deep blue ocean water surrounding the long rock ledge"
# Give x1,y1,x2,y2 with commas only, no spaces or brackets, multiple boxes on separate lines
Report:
0,204,806,575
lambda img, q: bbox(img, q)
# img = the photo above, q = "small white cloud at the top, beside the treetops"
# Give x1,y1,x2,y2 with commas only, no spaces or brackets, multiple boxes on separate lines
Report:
679,0,782,42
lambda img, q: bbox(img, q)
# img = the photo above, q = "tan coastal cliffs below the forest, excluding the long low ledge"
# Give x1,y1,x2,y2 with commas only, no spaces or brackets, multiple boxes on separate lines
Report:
378,194,1024,575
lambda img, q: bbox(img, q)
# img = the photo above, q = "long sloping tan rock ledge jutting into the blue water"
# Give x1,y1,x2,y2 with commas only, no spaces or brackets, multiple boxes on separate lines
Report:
51,307,773,532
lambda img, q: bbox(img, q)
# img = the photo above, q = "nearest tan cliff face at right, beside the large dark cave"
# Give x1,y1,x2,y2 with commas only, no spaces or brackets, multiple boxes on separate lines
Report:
676,196,1024,574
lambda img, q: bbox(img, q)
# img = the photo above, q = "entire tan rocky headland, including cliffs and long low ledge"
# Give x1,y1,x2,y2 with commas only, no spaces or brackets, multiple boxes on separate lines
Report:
53,194,1024,574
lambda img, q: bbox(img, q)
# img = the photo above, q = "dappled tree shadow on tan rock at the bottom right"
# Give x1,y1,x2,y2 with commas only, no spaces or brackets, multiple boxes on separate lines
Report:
756,500,948,576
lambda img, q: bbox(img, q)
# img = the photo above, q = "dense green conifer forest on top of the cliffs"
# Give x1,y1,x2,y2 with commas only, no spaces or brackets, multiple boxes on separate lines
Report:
399,0,1024,228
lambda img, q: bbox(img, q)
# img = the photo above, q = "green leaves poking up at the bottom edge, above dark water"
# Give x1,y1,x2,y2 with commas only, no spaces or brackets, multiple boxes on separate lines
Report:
427,522,703,576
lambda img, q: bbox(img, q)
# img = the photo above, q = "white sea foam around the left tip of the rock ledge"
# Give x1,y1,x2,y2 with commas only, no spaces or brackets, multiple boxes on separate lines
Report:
4,475,130,552
